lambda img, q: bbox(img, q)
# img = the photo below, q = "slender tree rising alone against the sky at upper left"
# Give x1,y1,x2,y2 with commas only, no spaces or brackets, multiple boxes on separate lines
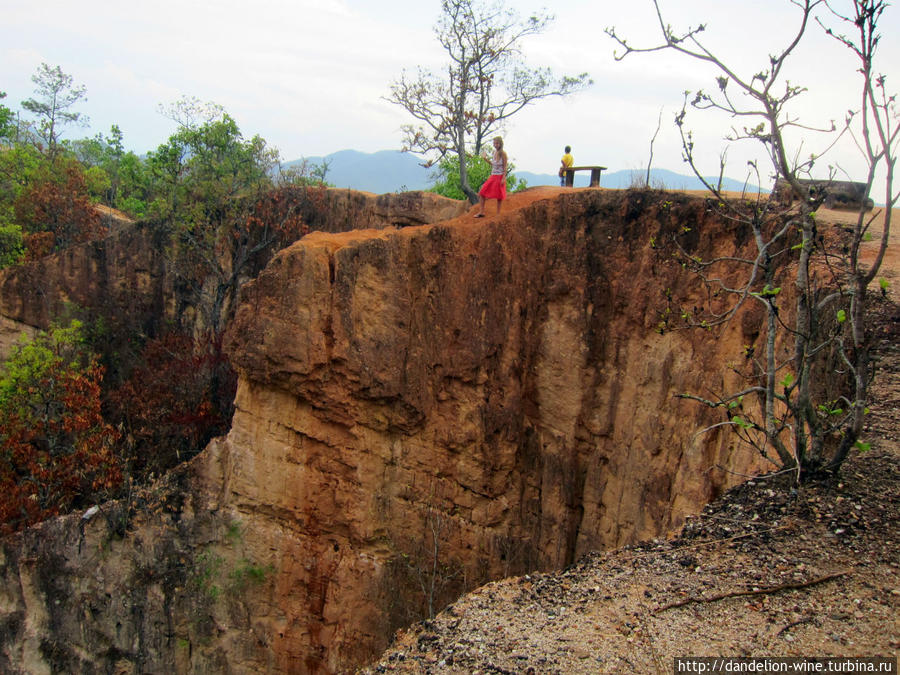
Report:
22,63,88,158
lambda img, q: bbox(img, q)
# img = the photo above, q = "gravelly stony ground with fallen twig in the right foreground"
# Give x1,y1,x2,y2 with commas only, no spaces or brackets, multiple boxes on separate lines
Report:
361,205,900,675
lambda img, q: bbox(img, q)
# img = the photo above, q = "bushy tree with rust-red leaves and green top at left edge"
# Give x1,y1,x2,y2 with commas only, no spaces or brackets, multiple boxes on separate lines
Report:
0,321,122,532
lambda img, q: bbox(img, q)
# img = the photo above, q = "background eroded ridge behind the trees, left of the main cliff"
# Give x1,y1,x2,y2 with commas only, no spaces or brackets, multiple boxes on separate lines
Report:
0,188,465,352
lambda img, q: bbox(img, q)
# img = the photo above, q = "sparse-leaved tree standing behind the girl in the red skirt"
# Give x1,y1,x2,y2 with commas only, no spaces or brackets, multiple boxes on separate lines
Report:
387,0,592,204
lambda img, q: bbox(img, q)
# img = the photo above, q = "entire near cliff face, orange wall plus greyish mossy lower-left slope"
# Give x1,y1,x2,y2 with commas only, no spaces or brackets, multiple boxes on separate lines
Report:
0,190,776,673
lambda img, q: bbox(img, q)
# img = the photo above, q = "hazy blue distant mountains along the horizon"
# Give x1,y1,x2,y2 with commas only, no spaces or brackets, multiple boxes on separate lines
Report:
286,150,756,194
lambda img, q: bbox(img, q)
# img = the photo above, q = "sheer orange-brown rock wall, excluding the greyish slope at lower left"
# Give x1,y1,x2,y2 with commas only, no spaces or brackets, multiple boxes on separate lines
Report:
218,191,772,671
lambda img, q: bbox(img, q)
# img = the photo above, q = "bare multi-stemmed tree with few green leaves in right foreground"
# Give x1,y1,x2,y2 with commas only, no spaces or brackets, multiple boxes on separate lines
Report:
607,0,900,476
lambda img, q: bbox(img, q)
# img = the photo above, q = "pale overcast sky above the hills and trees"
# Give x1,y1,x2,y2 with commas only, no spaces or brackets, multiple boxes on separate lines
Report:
0,0,900,185
